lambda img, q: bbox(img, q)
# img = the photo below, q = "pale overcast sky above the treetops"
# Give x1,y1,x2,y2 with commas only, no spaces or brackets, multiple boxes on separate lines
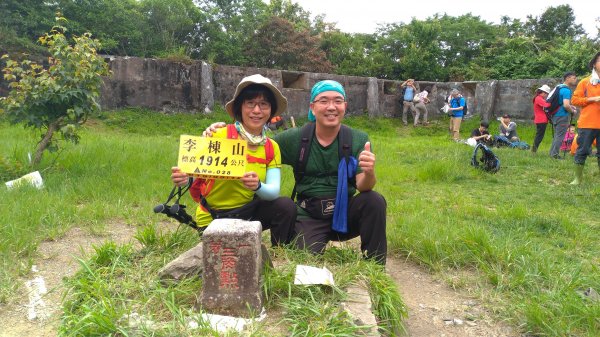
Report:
292,0,600,37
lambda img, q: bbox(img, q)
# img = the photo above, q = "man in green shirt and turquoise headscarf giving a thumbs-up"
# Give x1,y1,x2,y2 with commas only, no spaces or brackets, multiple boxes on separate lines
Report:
274,80,387,264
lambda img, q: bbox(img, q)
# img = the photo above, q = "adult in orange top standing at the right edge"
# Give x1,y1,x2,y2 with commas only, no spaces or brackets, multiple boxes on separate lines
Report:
571,52,600,185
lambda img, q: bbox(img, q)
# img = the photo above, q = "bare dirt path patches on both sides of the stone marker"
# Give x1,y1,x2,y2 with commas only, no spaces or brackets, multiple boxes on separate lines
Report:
0,223,519,337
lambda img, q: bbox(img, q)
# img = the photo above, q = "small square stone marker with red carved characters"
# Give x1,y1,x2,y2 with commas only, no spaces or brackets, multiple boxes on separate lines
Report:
200,219,262,317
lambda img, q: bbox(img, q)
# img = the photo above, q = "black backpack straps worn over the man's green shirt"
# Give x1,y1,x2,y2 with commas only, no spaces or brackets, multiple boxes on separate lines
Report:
292,122,356,200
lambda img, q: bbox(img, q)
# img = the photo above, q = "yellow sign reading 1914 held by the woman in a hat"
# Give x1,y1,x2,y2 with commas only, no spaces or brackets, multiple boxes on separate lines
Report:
177,135,248,179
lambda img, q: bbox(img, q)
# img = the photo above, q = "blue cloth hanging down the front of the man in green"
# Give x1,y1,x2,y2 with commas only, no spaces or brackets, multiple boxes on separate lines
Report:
331,156,358,233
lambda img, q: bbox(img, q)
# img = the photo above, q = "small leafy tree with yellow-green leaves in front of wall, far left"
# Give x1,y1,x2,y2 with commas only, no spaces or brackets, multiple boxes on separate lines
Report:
0,17,109,165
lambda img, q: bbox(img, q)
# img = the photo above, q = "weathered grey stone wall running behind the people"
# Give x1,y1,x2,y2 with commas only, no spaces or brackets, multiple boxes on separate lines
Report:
101,57,559,120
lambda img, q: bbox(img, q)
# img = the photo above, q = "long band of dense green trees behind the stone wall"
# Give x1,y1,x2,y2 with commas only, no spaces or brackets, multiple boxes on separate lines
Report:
0,0,600,82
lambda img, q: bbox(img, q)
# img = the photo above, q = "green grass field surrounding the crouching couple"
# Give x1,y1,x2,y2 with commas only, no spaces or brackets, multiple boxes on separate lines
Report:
0,110,600,336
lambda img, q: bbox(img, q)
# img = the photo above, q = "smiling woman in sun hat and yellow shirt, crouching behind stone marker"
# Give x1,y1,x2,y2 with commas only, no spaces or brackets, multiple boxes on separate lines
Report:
171,75,296,245
